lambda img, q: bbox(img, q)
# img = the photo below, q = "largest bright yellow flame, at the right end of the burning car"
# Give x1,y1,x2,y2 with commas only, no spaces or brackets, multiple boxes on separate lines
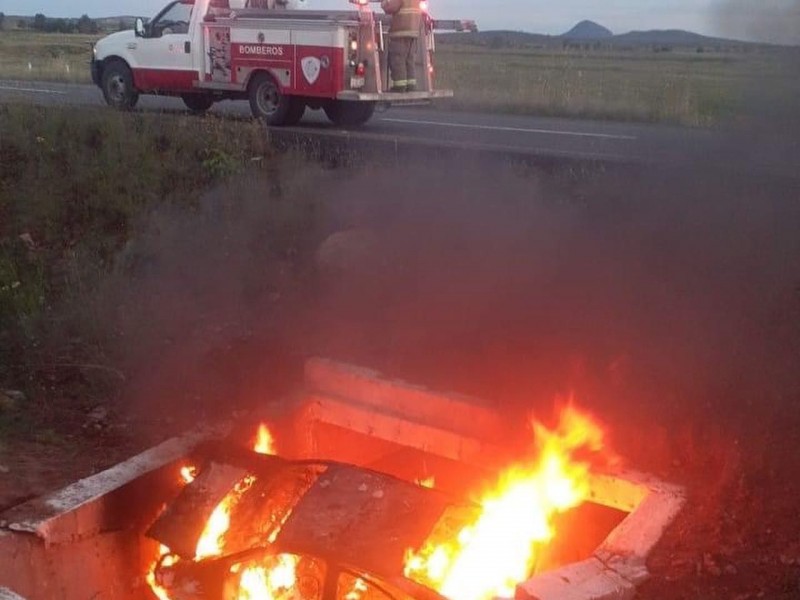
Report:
405,406,603,600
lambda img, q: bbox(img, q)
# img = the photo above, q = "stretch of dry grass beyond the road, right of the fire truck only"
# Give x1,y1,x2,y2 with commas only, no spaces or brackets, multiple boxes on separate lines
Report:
437,46,771,126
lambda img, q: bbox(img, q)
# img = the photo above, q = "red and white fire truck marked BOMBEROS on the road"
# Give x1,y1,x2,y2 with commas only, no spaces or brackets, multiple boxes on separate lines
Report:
91,0,476,126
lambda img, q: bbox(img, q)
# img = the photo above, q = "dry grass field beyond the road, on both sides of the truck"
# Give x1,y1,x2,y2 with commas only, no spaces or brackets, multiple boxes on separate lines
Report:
0,31,800,127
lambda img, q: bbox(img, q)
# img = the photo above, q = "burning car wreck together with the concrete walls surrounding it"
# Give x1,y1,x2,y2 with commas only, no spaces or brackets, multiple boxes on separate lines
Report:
0,359,684,600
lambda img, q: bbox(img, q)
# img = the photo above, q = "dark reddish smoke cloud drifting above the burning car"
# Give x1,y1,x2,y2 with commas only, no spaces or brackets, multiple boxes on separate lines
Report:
98,155,800,464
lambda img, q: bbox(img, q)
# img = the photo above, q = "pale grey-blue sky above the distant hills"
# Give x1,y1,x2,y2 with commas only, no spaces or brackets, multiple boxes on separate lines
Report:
0,0,800,41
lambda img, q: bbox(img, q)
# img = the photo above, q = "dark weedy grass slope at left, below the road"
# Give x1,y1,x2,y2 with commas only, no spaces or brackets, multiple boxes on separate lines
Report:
0,105,282,382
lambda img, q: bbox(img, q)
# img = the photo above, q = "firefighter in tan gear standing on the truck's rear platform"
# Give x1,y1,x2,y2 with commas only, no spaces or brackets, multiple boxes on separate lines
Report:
381,0,422,92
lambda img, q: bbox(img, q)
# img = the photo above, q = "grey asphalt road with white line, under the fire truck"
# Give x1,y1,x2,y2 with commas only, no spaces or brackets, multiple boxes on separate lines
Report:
0,81,800,175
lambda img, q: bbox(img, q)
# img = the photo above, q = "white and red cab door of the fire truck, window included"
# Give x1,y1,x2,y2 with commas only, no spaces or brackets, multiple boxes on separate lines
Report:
131,0,197,92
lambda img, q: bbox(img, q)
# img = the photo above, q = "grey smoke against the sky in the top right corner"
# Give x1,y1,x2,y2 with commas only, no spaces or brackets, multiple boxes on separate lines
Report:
713,0,800,45
